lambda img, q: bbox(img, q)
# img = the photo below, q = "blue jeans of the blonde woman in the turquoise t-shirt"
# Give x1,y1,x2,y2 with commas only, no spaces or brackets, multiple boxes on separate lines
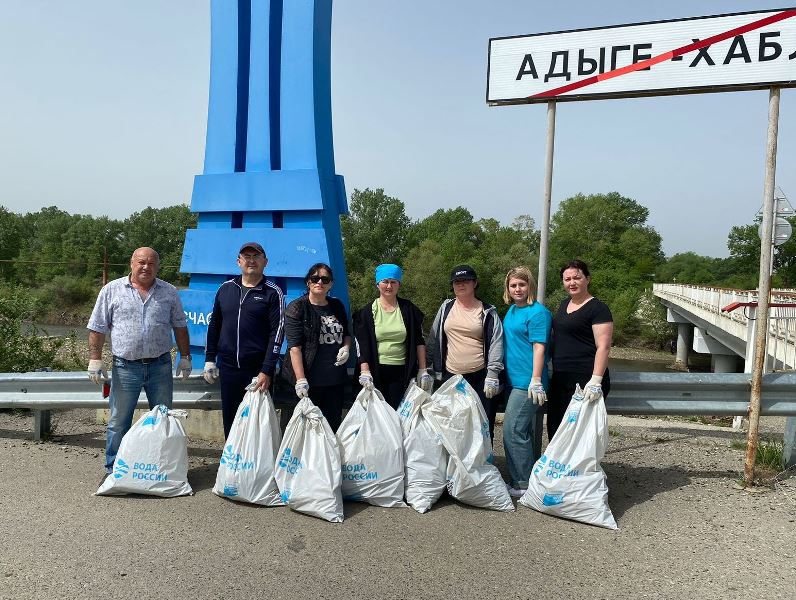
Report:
503,388,544,489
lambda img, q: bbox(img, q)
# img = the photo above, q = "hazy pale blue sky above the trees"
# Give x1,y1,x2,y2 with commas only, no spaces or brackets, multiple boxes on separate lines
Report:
0,0,796,256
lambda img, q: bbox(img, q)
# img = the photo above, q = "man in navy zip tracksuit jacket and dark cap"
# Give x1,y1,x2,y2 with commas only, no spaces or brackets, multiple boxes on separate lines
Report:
204,242,285,437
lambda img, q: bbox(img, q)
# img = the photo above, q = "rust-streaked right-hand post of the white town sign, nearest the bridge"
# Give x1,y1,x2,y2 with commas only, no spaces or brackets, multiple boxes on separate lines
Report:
744,87,779,485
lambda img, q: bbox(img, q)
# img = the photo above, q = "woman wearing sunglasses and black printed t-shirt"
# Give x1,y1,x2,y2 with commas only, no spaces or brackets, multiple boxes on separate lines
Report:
283,263,351,431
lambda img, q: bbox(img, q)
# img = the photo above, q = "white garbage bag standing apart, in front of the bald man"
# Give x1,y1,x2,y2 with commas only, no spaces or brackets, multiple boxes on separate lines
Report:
96,404,193,498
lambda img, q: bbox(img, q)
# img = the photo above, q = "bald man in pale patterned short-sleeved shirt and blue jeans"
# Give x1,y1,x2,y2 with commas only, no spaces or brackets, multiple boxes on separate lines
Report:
88,248,191,473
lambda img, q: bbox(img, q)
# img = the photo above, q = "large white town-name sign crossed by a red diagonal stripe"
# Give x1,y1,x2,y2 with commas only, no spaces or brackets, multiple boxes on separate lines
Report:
487,8,796,105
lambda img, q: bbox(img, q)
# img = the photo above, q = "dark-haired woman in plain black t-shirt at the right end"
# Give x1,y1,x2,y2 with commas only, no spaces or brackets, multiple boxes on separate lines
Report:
547,260,614,440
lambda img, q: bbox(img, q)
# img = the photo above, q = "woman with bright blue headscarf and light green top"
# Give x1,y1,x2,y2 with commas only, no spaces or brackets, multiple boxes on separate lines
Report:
354,264,433,408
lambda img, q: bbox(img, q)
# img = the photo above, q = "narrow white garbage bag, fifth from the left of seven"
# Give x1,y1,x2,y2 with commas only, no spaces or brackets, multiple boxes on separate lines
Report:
398,381,448,513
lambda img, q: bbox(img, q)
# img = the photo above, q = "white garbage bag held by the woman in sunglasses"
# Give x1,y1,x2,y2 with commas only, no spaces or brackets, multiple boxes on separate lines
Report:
274,398,343,523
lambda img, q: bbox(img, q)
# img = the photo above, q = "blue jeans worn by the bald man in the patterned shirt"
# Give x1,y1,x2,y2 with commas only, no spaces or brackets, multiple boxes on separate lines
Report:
105,352,174,473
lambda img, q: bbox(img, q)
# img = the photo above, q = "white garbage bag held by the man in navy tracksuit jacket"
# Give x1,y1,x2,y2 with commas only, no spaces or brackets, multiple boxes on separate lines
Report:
213,390,284,506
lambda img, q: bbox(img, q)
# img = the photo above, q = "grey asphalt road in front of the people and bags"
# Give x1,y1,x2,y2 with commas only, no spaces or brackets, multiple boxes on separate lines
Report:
0,411,796,600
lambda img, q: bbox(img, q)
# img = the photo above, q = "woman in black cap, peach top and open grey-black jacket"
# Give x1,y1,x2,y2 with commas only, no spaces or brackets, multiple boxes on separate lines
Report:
427,265,503,435
